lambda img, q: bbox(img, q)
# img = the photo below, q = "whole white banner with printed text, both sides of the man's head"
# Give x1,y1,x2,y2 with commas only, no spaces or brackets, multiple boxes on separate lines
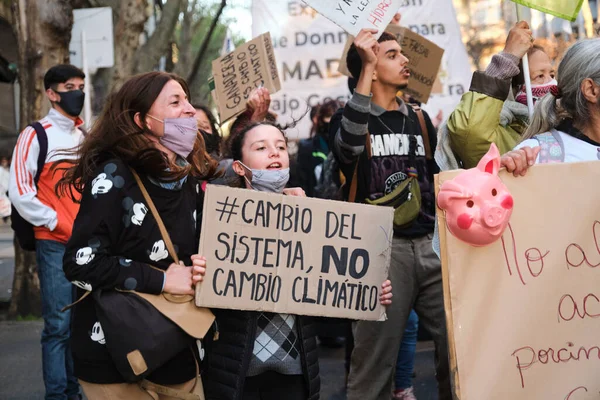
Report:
252,0,472,139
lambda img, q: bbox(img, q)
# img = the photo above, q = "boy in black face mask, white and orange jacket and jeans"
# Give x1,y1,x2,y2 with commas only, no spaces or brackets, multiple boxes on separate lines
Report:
9,64,85,400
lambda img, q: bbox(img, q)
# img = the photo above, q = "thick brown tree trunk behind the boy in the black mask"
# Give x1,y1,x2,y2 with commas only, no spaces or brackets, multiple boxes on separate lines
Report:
9,0,73,318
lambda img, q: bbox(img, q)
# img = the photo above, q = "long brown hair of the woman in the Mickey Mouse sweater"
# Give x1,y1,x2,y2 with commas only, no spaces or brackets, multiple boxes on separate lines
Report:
53,72,218,199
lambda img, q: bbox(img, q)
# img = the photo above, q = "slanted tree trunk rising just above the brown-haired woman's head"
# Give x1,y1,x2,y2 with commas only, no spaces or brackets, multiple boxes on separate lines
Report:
134,0,182,73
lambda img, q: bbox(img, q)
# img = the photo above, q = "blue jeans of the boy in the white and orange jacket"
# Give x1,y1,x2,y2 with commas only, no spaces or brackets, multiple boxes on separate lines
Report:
36,240,79,400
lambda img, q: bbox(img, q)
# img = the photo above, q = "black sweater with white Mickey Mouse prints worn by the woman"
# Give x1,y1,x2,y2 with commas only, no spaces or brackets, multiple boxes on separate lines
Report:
64,159,203,384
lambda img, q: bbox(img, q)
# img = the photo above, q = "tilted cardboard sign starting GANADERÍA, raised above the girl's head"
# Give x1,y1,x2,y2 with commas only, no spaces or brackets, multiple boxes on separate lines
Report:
212,32,281,123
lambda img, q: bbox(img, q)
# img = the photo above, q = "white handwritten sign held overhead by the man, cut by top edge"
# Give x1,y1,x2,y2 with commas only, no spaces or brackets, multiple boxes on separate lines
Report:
302,0,404,38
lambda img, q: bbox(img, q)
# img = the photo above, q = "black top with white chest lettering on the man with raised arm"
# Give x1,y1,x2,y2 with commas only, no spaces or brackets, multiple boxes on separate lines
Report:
330,93,439,237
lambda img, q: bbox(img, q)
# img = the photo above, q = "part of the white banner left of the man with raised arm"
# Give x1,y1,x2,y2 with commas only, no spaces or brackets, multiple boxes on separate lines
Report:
252,0,350,139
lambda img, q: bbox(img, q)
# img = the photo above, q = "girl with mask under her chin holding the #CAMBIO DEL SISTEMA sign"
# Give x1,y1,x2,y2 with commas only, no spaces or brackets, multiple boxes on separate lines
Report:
197,122,392,400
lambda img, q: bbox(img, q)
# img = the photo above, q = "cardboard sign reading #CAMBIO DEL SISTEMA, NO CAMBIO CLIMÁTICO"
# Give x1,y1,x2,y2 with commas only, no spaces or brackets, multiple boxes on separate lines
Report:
196,185,393,320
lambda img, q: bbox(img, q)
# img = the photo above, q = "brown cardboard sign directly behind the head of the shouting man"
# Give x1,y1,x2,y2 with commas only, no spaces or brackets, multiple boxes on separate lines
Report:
338,24,444,103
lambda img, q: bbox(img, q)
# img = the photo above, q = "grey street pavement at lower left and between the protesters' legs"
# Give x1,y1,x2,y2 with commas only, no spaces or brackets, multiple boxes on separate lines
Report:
0,221,438,400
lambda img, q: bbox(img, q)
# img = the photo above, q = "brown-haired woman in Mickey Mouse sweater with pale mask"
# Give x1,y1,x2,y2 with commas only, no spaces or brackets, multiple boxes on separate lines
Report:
57,72,217,400
